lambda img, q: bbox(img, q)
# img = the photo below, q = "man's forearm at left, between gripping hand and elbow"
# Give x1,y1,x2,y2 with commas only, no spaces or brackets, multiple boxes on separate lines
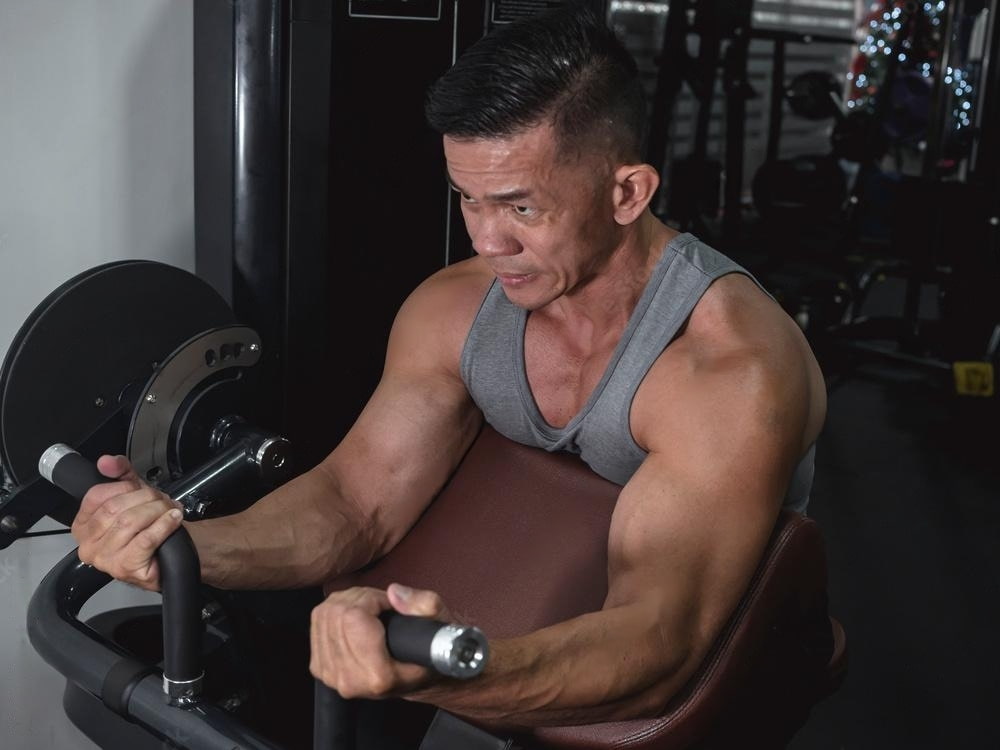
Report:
186,468,373,590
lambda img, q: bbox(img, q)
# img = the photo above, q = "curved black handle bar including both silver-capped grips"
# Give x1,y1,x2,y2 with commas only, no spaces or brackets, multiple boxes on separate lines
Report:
37,444,489,750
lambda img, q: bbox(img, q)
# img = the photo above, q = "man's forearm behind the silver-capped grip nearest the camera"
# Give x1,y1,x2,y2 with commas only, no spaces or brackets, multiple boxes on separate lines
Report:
408,604,697,727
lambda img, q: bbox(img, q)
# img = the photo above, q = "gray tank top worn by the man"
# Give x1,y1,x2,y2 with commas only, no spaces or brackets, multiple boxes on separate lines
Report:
461,234,815,512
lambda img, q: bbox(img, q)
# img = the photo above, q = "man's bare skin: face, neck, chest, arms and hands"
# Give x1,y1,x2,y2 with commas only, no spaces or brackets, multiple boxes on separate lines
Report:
73,124,826,727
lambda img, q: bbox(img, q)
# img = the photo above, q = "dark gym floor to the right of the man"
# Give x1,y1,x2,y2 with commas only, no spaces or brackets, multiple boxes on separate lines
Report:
790,342,1000,750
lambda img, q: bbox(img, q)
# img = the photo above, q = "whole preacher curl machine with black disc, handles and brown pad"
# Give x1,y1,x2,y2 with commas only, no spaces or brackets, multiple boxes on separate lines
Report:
0,261,846,750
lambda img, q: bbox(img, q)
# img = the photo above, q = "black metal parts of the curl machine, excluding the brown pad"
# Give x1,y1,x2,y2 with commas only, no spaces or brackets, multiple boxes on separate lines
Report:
0,261,488,750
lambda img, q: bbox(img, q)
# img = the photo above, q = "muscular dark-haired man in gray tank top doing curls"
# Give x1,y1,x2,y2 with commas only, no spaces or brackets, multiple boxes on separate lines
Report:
73,5,825,726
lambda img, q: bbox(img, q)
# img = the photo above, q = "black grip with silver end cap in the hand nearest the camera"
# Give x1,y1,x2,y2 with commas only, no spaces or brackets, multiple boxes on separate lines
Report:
382,612,489,679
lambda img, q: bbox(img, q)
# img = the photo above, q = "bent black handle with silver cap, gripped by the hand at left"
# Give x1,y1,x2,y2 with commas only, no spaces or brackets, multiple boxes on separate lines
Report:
38,443,204,705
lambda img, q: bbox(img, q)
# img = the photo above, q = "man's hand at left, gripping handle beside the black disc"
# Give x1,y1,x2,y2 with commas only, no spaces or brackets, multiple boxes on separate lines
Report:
72,456,183,591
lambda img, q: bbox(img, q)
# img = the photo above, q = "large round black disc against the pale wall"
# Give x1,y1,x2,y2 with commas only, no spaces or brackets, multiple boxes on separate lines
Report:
0,260,236,484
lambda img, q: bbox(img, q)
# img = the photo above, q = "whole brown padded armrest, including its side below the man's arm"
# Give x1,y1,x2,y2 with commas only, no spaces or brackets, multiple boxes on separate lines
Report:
327,427,832,750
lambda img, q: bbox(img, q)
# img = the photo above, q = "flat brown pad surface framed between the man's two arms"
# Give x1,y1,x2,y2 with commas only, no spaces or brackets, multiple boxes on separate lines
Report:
327,427,621,638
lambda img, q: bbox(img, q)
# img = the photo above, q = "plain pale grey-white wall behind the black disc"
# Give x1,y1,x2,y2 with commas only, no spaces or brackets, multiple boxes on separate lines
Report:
0,0,194,750
